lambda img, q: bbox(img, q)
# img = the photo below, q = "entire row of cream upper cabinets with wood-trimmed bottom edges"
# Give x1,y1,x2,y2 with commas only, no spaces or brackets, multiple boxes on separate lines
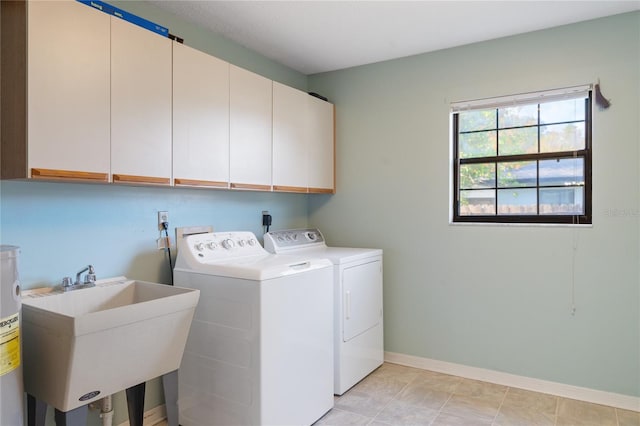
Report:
11,0,335,193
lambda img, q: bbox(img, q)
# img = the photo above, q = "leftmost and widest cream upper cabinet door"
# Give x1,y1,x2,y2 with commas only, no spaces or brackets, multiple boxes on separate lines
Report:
27,1,110,181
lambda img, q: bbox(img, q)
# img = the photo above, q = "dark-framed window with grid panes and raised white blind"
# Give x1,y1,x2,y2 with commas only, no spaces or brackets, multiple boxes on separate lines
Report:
452,87,591,224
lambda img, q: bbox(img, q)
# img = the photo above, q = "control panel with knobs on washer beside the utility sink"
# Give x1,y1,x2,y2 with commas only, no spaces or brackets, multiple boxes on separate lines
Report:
182,232,267,262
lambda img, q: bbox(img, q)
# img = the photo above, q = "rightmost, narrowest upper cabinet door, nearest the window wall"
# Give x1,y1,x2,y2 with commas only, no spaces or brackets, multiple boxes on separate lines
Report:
307,96,335,193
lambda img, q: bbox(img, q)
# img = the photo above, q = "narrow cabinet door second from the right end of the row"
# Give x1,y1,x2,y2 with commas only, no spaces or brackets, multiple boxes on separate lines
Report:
273,82,309,192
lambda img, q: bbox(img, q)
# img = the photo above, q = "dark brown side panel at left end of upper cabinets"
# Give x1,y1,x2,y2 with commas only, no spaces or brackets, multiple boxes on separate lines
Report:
0,0,28,179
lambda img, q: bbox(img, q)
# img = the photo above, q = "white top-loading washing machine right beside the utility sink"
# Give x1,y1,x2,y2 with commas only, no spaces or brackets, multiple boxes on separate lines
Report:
174,232,333,426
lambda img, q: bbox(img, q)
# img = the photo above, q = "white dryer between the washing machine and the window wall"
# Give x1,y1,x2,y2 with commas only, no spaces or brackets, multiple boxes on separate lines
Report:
264,229,384,395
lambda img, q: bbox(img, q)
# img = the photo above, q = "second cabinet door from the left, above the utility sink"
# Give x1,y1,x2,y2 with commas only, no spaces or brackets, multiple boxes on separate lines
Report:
111,18,171,184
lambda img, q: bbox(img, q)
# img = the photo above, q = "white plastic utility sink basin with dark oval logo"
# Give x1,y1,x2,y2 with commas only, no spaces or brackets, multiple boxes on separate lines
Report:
22,277,200,412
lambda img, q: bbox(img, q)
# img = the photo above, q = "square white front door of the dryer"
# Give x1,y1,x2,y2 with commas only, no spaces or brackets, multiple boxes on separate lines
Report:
342,260,382,342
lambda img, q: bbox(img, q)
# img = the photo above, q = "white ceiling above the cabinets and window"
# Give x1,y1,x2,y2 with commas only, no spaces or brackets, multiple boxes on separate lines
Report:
147,0,640,74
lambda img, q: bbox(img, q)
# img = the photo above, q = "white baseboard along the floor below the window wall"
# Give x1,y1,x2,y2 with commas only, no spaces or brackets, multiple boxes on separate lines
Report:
384,352,640,412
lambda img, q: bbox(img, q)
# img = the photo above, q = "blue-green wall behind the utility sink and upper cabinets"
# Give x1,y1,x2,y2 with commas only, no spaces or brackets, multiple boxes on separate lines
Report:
0,1,307,424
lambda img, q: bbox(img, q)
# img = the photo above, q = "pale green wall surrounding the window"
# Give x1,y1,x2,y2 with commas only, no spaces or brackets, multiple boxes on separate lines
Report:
309,13,640,396
